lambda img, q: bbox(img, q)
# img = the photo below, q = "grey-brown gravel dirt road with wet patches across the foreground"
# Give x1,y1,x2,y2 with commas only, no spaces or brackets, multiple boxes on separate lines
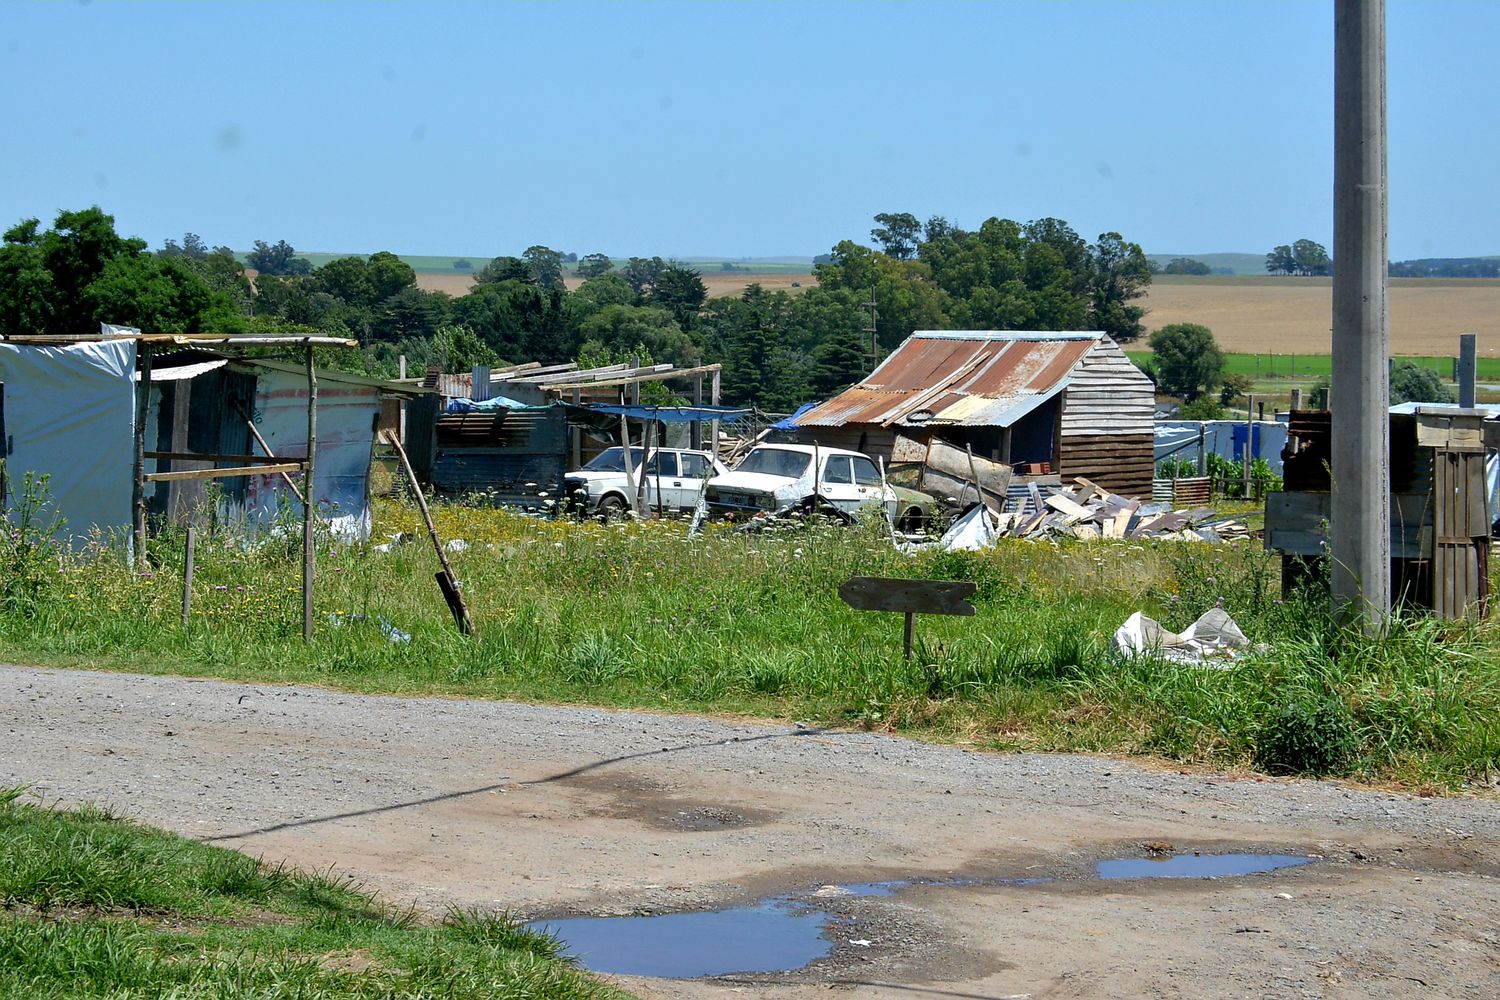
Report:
0,667,1500,1000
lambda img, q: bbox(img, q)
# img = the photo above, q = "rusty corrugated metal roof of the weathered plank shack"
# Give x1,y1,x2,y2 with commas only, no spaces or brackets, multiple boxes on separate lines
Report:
797,330,1104,427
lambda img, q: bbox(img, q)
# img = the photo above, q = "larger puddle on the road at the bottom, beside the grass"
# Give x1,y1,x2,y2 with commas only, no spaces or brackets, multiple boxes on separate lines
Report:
528,901,833,979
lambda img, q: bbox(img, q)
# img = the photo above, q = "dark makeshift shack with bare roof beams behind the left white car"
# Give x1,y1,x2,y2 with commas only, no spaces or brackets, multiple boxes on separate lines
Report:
404,363,720,510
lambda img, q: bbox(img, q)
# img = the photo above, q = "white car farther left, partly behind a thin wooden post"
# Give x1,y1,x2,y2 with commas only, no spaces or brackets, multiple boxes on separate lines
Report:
563,445,728,517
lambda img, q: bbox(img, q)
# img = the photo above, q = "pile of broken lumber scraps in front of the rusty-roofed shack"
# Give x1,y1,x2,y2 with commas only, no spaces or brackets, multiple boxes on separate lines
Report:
992,477,1250,541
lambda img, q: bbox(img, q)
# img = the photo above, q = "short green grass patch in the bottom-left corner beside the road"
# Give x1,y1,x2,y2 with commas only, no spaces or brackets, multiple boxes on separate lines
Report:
0,789,626,1000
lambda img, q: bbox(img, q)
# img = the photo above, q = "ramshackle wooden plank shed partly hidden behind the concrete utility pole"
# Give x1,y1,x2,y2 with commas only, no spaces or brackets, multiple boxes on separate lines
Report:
1266,403,1500,619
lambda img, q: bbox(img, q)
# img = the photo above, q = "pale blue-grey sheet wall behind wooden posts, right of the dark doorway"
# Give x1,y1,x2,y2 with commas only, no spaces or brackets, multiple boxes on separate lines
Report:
245,369,380,541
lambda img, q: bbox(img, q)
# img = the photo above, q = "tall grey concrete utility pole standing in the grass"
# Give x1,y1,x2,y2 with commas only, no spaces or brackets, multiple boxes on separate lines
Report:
1329,0,1391,634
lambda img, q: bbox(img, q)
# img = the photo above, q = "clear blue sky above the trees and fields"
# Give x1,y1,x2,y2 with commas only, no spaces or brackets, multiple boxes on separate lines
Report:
0,0,1500,259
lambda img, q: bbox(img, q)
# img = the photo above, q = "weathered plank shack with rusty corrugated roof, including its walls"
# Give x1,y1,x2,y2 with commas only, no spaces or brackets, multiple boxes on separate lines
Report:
791,330,1155,496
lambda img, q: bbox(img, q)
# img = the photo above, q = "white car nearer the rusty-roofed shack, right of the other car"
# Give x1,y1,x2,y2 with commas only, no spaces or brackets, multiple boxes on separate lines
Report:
704,444,897,517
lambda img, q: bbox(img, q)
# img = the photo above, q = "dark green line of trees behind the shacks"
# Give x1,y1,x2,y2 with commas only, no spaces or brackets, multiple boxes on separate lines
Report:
0,207,1152,411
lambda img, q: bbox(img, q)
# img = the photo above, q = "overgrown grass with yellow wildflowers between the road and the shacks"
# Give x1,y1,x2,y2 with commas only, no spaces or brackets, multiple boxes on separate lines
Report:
0,491,1500,787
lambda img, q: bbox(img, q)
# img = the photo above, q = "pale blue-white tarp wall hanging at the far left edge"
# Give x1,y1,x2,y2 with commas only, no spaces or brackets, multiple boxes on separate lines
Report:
0,340,135,544
